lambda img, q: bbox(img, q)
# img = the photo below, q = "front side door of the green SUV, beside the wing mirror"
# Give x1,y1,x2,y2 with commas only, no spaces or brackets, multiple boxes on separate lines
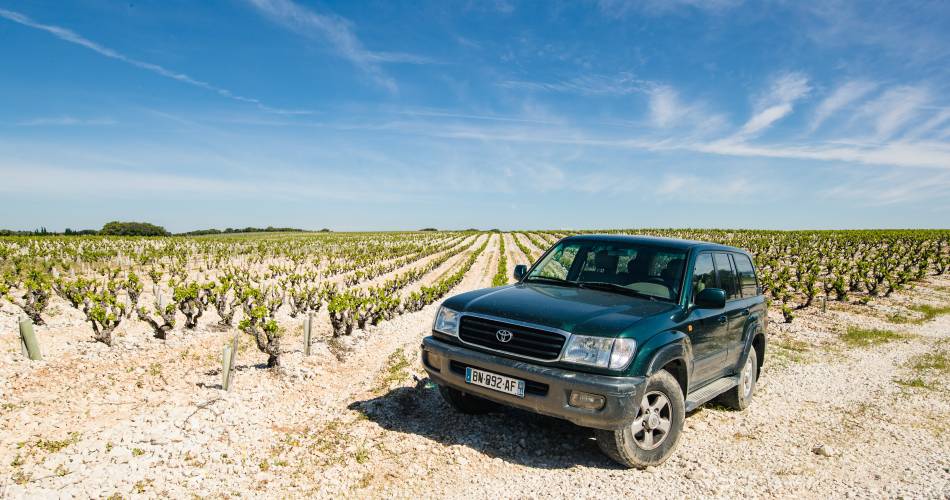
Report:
687,252,728,387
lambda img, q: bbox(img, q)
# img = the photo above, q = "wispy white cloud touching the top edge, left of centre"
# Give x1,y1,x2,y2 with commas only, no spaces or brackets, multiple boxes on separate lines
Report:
247,0,434,91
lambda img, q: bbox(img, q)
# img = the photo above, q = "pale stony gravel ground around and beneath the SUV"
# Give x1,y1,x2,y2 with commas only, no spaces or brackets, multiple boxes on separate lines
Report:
0,236,950,498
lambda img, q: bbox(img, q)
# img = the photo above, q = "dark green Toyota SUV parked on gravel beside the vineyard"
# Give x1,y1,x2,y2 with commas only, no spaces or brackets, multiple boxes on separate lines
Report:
422,235,767,468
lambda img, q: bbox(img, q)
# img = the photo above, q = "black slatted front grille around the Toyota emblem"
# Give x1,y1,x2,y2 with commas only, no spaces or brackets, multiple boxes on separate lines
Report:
459,316,565,360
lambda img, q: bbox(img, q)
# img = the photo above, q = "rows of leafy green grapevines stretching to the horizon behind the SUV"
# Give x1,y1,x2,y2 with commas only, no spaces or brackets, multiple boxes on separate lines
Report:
0,230,950,356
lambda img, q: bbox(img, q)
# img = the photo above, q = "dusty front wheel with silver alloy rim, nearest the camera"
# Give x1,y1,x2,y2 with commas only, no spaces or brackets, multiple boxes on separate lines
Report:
596,370,686,469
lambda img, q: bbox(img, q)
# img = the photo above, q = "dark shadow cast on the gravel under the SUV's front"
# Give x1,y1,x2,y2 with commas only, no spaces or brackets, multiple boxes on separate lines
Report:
349,378,622,469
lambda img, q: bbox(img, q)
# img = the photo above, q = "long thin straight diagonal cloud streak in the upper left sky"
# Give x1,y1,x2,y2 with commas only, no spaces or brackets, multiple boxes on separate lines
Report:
0,9,307,114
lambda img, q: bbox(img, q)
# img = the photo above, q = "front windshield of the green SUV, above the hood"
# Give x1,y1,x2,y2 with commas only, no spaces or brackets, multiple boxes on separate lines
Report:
525,241,686,302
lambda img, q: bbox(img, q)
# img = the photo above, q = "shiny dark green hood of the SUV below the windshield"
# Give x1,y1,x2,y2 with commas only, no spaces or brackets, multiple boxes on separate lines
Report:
443,283,677,337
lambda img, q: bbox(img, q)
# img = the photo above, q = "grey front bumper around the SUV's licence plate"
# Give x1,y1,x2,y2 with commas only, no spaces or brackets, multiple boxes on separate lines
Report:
422,337,645,429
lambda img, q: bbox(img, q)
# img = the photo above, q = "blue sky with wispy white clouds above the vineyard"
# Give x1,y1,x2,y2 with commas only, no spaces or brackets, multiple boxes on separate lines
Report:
0,0,950,230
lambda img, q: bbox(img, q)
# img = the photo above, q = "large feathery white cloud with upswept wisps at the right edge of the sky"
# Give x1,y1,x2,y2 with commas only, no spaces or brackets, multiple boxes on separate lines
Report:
490,72,950,174
